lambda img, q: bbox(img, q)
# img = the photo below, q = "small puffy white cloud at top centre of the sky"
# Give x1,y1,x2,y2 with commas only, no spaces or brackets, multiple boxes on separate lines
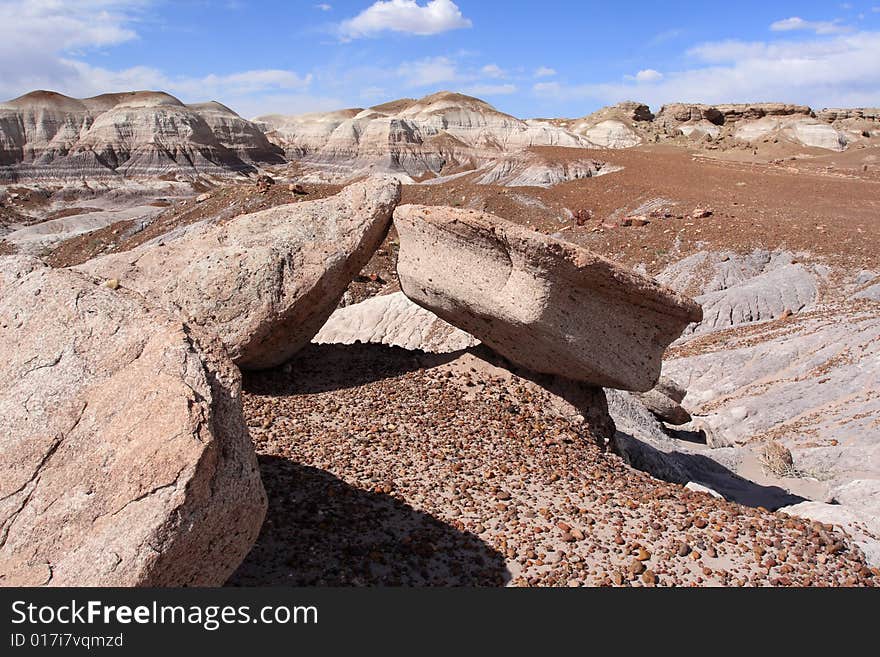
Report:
339,0,472,40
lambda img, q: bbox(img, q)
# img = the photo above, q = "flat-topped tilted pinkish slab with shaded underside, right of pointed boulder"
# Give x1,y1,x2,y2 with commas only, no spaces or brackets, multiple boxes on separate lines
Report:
394,205,702,392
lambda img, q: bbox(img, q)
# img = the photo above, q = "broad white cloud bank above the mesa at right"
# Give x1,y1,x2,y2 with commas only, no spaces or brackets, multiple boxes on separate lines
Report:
532,32,880,107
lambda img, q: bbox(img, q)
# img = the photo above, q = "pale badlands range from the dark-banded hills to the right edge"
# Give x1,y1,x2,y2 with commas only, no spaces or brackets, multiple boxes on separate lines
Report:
255,91,880,182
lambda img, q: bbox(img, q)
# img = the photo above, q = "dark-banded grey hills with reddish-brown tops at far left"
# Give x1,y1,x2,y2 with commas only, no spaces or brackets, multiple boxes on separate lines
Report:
0,91,283,182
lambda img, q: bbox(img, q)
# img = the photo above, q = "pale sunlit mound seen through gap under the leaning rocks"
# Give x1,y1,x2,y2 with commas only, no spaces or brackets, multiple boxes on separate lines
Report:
312,292,480,354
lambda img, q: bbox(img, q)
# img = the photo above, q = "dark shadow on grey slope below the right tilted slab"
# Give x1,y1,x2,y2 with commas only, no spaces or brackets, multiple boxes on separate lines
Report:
615,431,808,511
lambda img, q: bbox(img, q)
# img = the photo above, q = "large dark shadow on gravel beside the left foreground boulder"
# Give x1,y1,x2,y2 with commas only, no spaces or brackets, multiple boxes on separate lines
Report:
227,456,510,587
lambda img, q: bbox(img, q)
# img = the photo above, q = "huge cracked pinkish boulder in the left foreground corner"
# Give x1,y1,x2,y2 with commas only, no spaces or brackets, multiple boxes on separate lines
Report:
0,257,266,586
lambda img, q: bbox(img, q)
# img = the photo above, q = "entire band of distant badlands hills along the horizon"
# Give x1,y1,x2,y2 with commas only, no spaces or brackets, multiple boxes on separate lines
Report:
0,91,880,186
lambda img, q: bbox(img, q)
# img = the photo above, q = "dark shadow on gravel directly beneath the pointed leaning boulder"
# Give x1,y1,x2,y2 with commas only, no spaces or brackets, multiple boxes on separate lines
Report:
242,343,464,396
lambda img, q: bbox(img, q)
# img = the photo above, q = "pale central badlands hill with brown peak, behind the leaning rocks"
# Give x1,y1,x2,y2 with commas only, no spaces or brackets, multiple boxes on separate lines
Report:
256,91,596,184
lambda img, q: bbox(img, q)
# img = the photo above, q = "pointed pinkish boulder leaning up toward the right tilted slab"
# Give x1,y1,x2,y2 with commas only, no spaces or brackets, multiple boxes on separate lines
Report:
77,178,400,369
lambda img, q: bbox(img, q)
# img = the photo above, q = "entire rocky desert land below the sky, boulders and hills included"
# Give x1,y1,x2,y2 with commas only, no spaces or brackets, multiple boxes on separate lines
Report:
0,84,880,587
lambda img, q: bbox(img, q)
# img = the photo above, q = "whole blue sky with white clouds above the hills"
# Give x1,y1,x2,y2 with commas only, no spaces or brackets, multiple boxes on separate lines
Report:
0,0,880,117
